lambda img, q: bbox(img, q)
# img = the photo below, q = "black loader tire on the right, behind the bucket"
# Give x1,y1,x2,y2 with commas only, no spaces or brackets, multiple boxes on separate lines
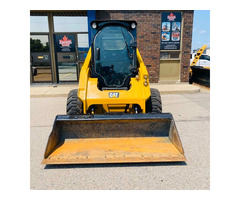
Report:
146,88,162,113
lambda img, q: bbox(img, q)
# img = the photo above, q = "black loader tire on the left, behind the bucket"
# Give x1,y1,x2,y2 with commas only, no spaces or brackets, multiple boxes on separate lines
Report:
66,89,83,115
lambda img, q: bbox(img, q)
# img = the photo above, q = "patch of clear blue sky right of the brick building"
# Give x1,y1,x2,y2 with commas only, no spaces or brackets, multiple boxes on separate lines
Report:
192,10,210,50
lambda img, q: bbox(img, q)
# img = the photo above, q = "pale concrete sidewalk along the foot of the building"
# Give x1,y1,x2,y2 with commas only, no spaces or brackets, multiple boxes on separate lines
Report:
30,83,200,97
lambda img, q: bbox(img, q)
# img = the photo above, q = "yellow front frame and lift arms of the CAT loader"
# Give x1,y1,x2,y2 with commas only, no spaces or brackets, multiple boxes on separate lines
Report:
78,48,151,114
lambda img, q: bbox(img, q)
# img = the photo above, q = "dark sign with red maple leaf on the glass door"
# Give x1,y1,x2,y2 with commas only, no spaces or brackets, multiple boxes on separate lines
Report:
55,35,75,52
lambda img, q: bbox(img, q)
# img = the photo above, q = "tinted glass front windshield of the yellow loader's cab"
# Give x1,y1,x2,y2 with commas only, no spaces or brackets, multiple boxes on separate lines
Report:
94,26,135,87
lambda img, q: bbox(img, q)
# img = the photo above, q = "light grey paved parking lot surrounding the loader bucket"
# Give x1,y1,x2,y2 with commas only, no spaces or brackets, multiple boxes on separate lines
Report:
30,88,210,190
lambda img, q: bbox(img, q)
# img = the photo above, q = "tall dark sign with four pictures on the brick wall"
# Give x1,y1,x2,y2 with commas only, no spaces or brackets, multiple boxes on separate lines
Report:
161,12,182,50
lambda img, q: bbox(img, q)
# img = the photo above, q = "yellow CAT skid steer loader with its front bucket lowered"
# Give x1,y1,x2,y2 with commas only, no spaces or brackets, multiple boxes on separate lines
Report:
42,21,186,165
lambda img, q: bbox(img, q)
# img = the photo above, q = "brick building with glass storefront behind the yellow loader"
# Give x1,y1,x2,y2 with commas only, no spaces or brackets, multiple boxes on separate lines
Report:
30,10,193,83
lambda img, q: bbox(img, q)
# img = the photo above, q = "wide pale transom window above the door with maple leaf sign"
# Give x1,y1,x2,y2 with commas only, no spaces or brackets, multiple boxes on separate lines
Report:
53,16,88,32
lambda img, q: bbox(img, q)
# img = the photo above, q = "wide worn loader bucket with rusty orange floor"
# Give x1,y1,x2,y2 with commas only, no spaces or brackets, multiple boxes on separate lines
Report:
42,113,186,165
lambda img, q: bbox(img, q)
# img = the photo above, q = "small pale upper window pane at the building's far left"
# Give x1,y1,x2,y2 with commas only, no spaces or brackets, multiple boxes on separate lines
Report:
30,16,49,33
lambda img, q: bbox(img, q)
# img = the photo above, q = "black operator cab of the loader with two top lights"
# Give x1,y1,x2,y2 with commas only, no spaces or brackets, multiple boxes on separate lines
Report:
91,21,137,90
